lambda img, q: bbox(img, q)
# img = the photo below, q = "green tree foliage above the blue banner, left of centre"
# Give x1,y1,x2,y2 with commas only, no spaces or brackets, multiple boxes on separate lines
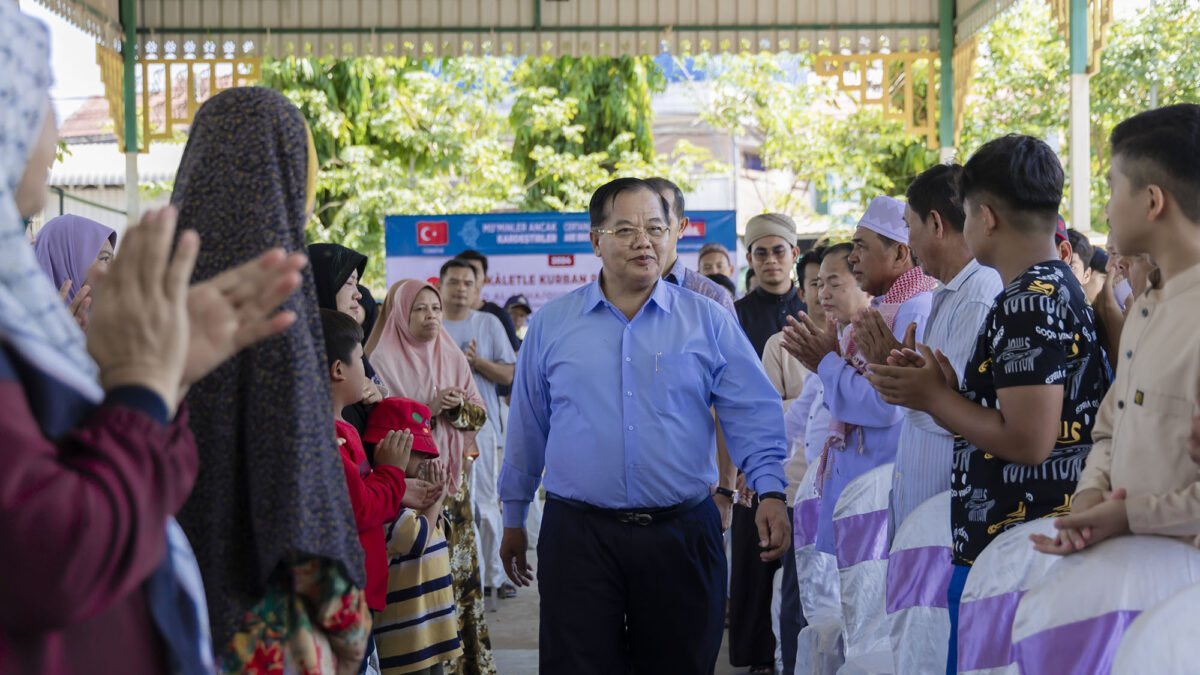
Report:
263,56,721,291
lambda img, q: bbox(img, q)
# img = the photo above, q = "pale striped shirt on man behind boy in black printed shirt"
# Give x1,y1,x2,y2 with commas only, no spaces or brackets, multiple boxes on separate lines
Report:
888,259,1004,534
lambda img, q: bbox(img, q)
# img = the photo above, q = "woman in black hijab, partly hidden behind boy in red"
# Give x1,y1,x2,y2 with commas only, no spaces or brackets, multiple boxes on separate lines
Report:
308,244,385,436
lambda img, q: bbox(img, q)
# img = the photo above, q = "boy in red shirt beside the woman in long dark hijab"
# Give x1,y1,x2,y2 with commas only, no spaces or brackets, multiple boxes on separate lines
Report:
320,310,413,612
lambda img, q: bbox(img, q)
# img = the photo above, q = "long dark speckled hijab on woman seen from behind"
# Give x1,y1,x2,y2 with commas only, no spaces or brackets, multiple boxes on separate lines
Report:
172,88,365,651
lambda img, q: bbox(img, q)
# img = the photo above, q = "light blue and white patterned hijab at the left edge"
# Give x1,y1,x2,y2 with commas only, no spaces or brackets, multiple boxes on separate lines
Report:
0,9,103,402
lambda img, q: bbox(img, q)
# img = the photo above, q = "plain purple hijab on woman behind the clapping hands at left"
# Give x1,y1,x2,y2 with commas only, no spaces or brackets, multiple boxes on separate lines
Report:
34,215,116,303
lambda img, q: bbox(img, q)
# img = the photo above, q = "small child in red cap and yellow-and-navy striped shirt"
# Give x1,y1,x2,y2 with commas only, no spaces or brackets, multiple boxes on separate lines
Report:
365,399,462,675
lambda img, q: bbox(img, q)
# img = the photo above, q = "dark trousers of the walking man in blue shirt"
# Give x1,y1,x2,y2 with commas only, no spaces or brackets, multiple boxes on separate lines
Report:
538,498,724,675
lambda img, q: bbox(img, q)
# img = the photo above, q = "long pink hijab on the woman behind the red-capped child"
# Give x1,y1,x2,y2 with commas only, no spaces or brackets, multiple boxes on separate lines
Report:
370,279,484,495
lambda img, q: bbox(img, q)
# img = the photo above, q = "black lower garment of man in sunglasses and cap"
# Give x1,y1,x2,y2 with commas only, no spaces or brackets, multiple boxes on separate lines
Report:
730,497,796,667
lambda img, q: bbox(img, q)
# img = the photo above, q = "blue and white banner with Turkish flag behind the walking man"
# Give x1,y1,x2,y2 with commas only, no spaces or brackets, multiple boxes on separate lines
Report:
384,211,738,311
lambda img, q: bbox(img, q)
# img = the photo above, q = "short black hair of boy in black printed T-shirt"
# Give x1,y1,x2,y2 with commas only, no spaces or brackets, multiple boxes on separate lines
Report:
959,133,1063,234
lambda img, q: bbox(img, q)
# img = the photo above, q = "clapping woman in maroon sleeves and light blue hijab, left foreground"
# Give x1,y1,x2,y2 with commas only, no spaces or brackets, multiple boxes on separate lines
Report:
0,2,302,675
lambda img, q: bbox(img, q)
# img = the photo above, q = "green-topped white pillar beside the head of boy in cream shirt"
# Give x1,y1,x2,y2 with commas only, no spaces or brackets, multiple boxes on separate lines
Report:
1068,0,1092,232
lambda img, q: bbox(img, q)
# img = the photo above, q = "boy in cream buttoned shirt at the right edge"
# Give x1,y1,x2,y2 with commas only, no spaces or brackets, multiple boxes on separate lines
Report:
1034,104,1200,555
